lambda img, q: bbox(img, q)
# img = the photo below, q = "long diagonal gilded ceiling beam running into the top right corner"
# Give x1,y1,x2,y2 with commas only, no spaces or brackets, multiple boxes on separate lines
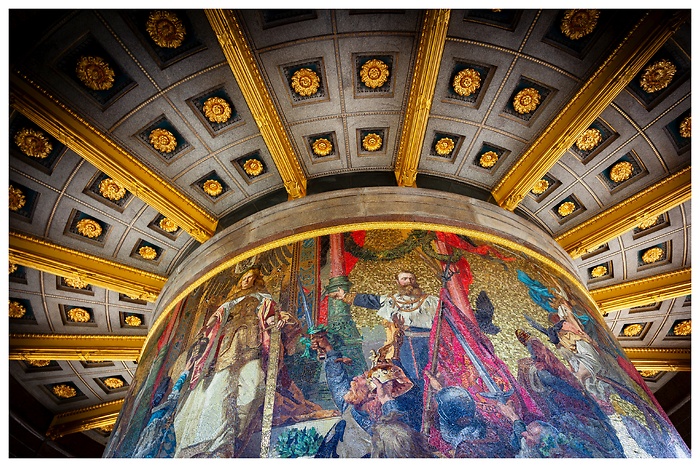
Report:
491,10,688,211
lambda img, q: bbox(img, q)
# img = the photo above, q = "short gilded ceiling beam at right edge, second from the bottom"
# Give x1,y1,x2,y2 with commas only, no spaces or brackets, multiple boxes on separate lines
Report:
590,268,691,314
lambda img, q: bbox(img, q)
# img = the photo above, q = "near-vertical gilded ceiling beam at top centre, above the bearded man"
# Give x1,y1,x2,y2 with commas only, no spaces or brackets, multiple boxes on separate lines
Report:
394,10,450,187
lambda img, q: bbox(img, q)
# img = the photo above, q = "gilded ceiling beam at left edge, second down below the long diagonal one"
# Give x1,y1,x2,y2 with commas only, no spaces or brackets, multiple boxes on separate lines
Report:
9,231,168,302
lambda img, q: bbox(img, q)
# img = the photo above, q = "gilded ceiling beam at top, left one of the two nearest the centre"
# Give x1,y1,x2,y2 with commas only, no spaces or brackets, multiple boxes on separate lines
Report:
205,10,306,199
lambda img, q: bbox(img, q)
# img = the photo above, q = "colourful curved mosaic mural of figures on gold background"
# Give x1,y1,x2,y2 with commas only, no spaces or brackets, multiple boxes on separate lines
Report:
105,230,689,458
